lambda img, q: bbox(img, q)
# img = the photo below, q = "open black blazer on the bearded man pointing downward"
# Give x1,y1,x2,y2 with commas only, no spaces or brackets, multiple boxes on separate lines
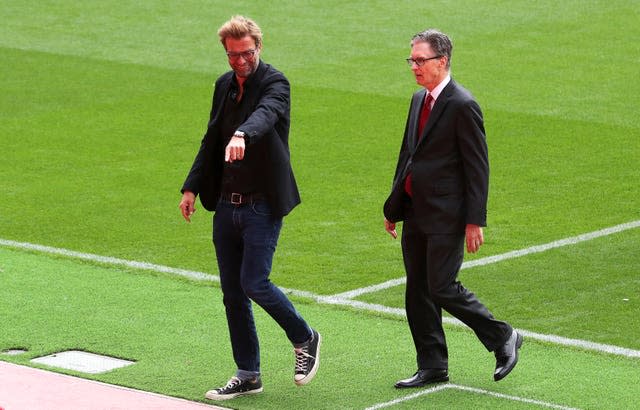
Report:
181,61,300,217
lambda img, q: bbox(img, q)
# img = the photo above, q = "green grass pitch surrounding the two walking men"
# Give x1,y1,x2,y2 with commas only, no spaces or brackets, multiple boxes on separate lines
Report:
0,0,640,409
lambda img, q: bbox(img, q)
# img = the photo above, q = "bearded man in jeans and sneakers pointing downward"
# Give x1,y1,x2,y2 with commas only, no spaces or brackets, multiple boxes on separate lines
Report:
180,16,321,400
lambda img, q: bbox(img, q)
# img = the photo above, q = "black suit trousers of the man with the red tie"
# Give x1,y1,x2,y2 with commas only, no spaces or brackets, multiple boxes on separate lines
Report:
402,209,512,369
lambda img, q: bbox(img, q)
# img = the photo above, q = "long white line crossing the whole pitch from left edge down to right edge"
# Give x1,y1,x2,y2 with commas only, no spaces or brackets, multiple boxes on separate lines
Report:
0,231,640,358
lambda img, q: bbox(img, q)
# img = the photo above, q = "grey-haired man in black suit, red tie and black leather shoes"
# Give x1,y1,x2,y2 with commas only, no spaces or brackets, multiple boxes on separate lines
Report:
384,30,522,388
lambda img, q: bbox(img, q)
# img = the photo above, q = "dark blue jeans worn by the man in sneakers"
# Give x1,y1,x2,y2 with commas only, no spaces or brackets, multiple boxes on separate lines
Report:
213,201,311,372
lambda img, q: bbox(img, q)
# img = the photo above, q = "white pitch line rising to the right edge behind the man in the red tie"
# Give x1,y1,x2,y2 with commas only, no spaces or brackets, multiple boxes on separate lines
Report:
333,221,640,299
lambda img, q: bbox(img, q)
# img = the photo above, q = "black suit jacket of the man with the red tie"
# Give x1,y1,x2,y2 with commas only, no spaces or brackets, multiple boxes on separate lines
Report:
384,80,489,233
